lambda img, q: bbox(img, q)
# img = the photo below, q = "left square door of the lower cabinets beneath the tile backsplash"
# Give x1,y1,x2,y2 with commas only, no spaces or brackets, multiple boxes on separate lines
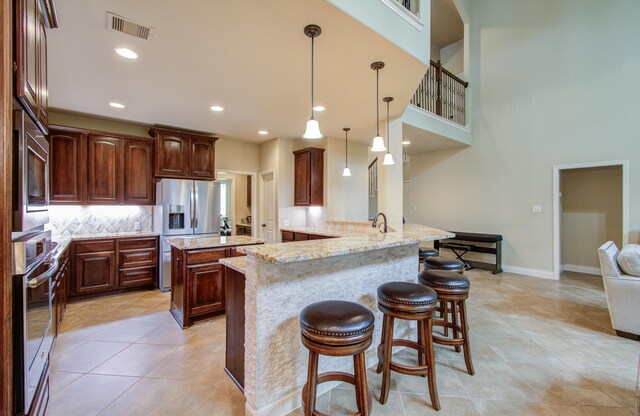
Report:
74,251,117,295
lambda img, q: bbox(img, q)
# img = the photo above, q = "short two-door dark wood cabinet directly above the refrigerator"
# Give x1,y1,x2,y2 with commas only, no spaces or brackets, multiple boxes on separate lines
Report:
149,127,218,180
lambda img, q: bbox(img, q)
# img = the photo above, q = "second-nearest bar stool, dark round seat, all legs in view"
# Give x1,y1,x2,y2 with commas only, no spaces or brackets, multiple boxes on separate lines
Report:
376,282,440,410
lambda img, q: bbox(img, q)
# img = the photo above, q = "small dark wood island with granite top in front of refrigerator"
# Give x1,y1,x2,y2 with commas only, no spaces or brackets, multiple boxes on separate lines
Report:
166,236,263,328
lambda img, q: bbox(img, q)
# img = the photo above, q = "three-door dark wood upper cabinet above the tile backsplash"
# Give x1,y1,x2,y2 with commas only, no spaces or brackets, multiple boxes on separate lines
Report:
49,126,155,205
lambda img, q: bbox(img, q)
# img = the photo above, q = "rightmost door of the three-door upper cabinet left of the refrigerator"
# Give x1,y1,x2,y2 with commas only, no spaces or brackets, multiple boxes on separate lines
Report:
124,140,155,205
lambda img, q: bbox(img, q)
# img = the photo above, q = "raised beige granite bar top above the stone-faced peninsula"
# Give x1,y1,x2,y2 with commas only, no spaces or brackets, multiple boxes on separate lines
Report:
238,221,455,263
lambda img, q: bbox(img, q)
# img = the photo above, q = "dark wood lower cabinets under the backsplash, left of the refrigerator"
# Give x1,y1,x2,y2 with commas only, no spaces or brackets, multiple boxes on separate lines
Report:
69,237,158,296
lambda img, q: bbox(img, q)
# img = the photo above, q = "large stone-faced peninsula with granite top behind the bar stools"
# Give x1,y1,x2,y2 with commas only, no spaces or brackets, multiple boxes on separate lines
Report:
221,221,454,415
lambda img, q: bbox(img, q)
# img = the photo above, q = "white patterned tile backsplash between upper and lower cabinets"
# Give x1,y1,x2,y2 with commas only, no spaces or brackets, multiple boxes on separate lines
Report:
49,205,153,236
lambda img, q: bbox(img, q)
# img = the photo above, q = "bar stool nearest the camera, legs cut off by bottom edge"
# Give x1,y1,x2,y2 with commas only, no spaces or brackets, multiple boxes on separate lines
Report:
300,300,375,416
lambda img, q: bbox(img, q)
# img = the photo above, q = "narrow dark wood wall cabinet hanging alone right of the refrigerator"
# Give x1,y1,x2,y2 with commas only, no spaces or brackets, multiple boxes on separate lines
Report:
293,147,324,206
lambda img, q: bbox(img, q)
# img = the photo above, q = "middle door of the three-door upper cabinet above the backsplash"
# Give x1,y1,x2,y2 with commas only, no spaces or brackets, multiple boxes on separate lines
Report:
87,134,124,204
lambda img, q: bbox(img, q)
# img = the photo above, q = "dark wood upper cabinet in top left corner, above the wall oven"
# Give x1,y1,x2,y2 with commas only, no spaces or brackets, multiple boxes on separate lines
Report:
15,0,58,134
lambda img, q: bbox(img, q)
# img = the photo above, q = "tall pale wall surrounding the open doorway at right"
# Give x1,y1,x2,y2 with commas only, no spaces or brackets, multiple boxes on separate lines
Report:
412,0,640,277
